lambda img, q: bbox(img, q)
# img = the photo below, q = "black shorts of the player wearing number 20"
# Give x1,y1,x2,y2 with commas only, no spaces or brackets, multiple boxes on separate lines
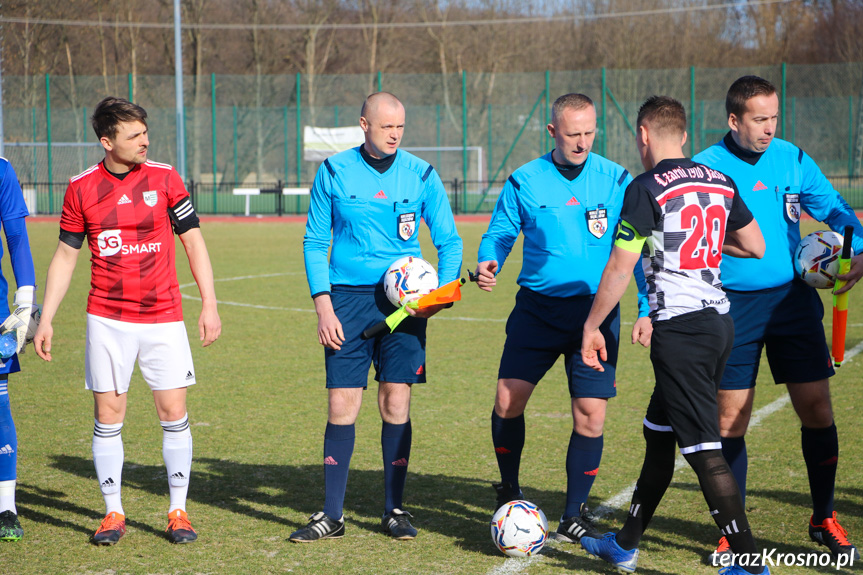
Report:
644,308,734,455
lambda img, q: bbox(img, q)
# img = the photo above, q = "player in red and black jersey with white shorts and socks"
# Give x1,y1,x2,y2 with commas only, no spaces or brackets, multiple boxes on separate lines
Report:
34,97,222,545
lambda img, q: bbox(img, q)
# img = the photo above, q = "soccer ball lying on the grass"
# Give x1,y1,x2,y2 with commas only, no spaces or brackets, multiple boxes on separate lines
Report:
491,499,548,557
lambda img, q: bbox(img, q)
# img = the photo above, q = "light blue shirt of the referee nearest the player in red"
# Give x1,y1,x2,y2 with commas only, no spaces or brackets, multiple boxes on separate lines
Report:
303,147,462,297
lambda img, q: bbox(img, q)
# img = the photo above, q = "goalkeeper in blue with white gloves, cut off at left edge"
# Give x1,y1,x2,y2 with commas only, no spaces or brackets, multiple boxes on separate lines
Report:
0,158,39,541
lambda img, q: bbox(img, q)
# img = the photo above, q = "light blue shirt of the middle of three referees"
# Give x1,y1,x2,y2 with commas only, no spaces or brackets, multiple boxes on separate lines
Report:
478,153,647,315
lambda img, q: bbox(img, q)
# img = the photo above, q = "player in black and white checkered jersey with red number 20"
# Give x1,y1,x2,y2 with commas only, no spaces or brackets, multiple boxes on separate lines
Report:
581,96,769,575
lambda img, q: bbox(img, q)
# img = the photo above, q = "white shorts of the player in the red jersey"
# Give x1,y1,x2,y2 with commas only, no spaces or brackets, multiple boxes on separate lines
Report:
84,313,195,393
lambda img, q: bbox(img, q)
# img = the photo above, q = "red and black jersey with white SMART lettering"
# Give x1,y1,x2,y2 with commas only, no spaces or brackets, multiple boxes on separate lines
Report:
60,162,188,323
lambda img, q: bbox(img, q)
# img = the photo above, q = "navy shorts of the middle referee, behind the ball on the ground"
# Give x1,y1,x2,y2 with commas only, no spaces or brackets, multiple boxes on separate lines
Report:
497,287,620,397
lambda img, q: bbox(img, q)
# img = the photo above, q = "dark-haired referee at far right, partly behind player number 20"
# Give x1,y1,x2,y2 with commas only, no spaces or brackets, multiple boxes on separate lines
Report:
694,76,863,560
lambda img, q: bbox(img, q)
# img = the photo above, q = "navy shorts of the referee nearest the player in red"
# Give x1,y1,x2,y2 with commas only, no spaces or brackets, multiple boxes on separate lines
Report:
324,284,428,388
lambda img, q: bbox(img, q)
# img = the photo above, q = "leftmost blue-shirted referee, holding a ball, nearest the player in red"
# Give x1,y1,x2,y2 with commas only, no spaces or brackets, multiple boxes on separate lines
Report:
290,92,462,543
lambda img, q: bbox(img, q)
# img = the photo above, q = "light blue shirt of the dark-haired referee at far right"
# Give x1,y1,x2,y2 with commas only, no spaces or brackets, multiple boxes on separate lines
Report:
693,138,863,291
